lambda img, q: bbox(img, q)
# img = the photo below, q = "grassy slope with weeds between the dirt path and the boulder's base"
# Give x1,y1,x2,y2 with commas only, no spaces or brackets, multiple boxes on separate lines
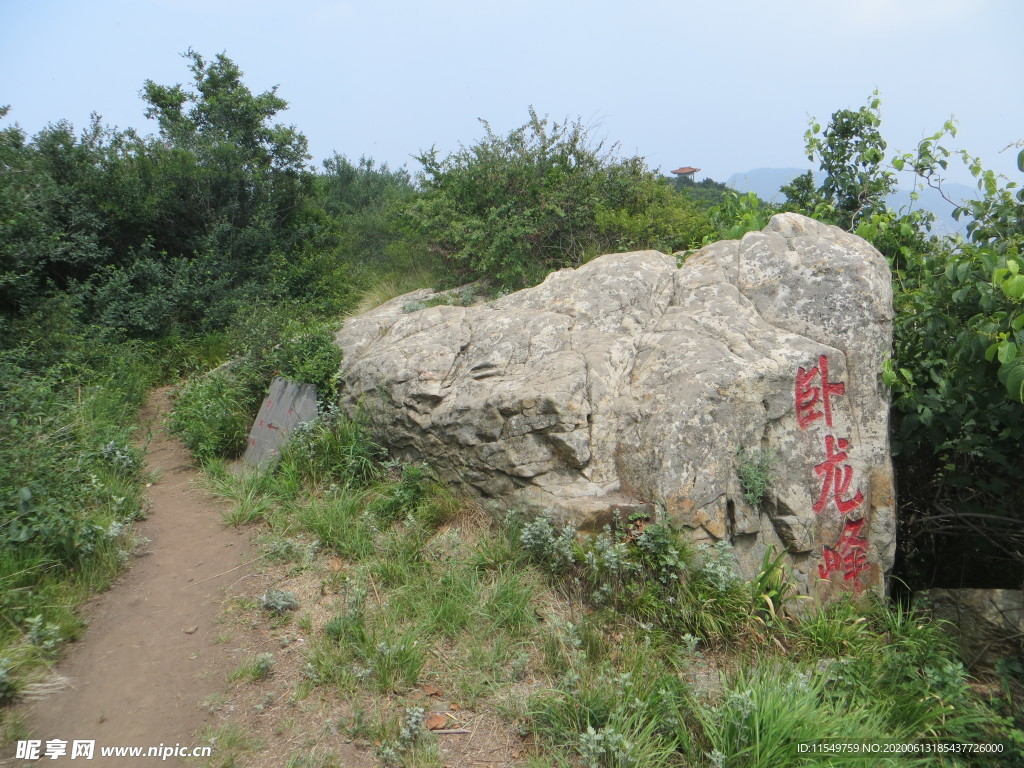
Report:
188,419,1020,768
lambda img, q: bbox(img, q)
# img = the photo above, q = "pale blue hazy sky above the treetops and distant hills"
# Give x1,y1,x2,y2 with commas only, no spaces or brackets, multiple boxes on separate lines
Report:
0,0,1024,186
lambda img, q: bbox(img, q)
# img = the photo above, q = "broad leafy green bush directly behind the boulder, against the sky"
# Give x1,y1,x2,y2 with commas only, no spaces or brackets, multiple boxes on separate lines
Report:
412,109,712,288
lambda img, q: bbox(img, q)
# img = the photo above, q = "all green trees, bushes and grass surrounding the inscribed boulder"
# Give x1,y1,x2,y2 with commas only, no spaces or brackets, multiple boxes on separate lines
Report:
0,51,1024,766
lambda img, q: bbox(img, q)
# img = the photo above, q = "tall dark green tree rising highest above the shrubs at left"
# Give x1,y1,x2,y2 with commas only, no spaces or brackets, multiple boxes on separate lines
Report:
84,50,317,336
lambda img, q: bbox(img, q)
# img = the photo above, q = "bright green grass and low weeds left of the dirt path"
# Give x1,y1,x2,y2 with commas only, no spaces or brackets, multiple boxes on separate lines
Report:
0,335,154,699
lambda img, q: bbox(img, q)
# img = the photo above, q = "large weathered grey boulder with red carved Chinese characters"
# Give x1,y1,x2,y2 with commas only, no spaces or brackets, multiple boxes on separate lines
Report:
337,214,895,599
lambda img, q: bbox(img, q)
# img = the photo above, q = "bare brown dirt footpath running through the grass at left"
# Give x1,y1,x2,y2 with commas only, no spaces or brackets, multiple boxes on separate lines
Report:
22,389,253,766
